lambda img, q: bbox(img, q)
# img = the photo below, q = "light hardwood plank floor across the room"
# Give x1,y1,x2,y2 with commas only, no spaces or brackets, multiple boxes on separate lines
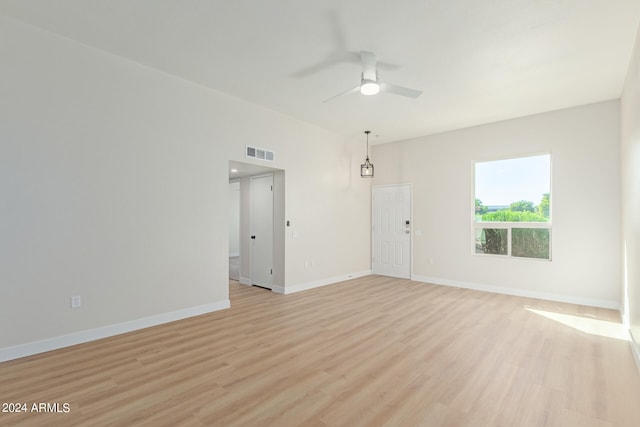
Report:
0,276,640,427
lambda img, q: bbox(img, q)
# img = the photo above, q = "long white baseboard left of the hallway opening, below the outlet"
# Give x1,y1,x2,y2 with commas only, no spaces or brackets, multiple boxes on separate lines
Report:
0,299,230,362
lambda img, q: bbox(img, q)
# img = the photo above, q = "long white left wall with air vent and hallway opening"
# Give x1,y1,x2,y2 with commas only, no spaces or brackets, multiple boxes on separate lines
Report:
0,15,369,360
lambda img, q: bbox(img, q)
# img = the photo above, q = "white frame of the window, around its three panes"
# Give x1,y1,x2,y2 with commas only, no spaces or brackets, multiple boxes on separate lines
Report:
471,152,553,262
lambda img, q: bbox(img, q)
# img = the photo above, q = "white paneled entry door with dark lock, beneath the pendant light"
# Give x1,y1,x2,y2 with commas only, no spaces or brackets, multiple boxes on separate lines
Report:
372,184,411,279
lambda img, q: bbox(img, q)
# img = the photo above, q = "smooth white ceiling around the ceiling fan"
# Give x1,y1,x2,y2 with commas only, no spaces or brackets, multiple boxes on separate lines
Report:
0,0,640,143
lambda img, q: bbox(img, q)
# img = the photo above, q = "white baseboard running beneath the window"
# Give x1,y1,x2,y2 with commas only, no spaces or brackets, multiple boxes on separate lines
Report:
411,275,620,310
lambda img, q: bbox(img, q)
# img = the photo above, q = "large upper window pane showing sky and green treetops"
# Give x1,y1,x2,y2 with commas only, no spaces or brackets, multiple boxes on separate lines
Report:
475,154,551,222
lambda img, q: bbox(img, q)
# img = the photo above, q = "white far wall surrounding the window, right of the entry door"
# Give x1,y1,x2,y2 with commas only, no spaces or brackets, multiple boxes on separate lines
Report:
372,101,620,307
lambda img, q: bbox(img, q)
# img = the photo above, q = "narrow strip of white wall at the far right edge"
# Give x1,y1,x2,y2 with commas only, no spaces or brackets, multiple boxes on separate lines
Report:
620,21,640,369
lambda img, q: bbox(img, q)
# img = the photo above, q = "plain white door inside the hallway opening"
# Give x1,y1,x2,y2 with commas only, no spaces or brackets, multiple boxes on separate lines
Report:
250,174,273,289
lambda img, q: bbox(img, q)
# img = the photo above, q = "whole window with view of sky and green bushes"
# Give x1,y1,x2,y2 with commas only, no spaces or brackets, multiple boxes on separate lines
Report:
473,154,551,260
